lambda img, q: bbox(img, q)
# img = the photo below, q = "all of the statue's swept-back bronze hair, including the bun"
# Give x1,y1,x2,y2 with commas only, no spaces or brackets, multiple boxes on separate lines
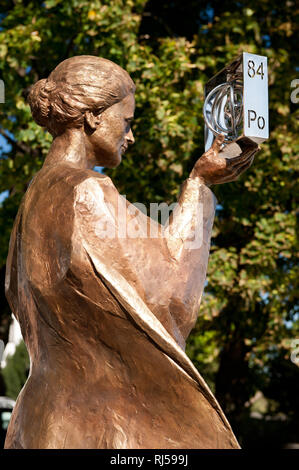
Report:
27,55,135,138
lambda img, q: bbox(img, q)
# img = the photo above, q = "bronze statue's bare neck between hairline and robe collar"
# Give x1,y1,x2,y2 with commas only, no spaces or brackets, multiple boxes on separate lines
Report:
43,129,96,169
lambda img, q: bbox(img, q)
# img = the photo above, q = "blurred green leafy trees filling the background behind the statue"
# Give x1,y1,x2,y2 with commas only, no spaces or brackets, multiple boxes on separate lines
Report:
0,0,299,448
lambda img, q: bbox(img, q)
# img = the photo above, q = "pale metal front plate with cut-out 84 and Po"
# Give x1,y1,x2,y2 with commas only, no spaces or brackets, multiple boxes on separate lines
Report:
243,52,269,142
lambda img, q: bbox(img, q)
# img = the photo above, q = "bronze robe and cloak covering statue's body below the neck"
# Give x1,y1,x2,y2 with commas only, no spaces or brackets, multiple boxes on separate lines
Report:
5,164,239,449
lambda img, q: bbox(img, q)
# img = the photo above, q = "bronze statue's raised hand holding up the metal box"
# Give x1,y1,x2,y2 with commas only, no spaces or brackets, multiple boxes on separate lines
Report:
190,135,260,185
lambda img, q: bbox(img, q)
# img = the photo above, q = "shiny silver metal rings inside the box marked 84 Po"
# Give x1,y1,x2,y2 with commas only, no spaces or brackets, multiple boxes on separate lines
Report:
203,80,243,142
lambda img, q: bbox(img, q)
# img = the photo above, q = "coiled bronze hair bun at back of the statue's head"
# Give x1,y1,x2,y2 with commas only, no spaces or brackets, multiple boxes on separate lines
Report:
27,78,56,127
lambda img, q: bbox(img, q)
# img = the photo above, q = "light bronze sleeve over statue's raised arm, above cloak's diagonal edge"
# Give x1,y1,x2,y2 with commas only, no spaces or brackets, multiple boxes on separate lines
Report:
75,177,215,340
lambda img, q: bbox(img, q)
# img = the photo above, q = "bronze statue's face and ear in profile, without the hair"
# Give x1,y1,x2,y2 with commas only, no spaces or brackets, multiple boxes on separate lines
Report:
85,93,135,168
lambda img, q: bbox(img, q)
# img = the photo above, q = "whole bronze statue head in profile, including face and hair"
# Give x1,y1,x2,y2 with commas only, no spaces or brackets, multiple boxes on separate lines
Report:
28,55,135,168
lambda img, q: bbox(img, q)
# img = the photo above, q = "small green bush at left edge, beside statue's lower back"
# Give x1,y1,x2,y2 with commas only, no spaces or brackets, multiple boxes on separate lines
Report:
1,341,30,399
